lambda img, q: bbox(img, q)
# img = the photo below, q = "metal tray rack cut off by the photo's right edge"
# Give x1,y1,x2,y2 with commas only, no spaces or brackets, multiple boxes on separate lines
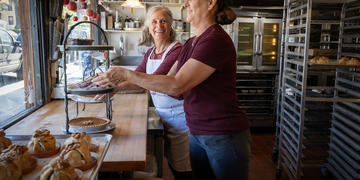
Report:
325,1,360,180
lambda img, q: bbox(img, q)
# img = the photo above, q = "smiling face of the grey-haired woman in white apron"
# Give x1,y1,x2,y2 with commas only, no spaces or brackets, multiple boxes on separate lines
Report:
149,10,171,41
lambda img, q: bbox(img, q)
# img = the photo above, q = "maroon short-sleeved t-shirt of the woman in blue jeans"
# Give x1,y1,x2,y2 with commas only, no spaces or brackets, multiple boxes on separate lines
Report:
177,24,249,135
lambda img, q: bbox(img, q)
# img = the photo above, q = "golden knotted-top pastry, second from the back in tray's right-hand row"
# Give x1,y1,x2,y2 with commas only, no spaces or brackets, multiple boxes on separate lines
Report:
60,142,91,167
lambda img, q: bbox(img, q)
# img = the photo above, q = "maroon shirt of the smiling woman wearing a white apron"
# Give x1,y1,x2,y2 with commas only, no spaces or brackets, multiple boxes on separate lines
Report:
135,43,182,75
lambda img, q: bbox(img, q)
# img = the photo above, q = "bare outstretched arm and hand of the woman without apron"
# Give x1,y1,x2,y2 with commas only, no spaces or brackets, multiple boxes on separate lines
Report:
93,58,215,96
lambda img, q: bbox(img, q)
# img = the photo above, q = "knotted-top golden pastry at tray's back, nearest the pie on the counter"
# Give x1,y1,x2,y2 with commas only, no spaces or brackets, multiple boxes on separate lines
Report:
27,129,60,158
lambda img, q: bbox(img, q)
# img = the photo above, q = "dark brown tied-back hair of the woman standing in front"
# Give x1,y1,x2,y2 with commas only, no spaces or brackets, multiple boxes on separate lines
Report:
215,0,236,25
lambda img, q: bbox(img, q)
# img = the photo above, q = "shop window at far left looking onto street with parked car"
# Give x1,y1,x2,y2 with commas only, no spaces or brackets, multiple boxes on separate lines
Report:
0,0,46,128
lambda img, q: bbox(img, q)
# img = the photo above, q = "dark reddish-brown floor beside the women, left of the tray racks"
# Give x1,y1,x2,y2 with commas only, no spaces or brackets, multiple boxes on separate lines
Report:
163,133,276,180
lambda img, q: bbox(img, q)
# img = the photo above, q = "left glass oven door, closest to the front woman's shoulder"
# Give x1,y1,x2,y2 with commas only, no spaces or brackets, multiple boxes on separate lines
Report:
235,22,255,66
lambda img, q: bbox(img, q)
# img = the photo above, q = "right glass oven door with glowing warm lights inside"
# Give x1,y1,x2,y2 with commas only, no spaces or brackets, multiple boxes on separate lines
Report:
260,22,281,69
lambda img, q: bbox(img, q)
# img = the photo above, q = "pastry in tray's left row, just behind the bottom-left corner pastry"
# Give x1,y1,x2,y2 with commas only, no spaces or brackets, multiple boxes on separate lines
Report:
2,144,36,174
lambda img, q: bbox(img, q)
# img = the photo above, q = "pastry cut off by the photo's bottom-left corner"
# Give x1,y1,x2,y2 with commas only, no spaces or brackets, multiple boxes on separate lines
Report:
0,153,22,180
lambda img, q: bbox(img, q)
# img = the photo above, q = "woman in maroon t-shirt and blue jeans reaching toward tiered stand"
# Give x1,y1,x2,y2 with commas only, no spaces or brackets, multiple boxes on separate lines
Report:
93,0,250,180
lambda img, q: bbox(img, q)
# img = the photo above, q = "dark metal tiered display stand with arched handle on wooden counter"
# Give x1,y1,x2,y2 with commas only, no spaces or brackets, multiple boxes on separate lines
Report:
60,21,114,134
